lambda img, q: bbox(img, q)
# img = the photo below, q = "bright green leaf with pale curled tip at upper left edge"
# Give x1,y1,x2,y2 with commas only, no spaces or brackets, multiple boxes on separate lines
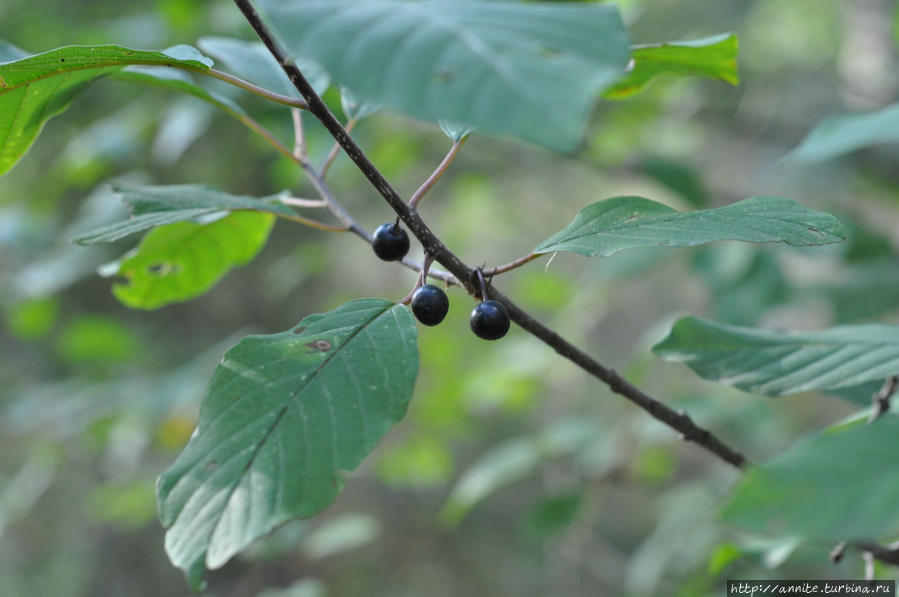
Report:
0,46,212,175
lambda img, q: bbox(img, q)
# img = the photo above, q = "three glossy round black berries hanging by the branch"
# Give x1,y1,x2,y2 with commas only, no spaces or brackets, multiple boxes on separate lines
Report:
372,222,509,340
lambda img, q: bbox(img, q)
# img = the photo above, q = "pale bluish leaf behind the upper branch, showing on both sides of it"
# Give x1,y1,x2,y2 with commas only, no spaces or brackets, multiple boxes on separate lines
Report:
197,37,331,98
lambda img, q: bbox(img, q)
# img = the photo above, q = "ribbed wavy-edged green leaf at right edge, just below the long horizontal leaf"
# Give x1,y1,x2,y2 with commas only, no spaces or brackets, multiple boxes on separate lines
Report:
653,317,899,396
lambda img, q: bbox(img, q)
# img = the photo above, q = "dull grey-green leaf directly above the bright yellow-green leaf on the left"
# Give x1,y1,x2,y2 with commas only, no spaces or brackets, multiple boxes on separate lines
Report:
72,185,294,244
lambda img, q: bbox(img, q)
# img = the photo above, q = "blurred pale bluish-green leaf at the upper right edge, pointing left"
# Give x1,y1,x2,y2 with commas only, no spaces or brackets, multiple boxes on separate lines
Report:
784,104,899,163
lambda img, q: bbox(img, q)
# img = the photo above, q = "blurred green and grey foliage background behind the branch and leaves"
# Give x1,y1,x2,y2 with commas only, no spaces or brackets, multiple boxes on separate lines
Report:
0,0,899,597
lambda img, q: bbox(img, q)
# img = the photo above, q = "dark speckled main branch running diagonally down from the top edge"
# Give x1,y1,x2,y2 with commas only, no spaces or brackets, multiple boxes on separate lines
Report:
234,0,747,468
